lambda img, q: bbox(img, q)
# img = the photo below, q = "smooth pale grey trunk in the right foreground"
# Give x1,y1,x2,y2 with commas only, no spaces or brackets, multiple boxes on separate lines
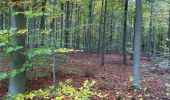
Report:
133,0,142,89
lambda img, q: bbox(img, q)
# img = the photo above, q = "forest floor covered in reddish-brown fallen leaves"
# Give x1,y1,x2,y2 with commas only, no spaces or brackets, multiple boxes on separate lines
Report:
0,53,170,100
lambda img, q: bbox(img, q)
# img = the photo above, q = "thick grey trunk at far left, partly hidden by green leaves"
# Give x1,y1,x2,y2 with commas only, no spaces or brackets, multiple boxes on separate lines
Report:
8,0,26,96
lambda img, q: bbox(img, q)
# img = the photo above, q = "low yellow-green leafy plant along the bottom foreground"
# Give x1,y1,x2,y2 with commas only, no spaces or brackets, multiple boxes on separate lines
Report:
9,80,108,100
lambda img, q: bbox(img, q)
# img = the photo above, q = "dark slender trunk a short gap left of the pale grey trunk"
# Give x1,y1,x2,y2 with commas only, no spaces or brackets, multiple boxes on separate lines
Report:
122,0,128,65
